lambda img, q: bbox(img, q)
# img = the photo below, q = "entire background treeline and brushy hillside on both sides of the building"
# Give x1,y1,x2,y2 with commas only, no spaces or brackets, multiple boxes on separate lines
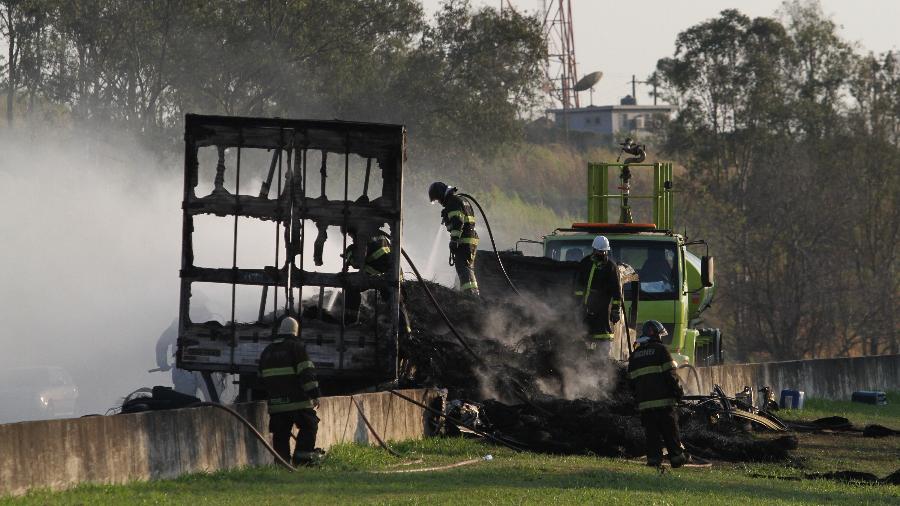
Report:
0,0,900,360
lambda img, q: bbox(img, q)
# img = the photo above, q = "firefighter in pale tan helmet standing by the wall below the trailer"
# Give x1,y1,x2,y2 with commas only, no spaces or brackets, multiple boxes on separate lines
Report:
259,317,320,465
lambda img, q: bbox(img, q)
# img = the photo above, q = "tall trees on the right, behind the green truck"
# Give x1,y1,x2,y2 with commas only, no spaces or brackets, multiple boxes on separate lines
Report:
654,1,900,360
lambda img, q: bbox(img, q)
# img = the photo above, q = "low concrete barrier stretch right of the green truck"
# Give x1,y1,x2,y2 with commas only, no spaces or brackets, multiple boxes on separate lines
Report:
679,355,900,401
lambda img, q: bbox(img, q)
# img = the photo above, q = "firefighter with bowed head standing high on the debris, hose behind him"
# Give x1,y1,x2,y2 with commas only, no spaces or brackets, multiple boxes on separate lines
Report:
428,181,479,296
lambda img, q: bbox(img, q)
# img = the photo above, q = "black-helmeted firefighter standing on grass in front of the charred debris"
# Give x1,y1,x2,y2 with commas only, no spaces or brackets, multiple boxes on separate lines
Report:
628,320,690,468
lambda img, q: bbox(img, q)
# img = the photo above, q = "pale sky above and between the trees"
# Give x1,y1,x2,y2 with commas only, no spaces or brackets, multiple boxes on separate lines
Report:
423,0,900,106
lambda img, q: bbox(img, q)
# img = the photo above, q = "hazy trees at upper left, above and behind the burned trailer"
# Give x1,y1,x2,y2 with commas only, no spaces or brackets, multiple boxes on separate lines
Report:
0,0,545,150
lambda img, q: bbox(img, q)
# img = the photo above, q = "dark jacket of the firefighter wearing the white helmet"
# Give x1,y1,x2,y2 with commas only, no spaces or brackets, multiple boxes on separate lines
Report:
575,255,622,318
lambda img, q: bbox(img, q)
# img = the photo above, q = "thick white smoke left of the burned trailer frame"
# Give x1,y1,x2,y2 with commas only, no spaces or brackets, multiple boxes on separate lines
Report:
0,125,180,414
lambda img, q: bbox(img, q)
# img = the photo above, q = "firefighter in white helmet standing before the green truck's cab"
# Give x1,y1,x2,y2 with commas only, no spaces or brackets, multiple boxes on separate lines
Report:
574,235,623,357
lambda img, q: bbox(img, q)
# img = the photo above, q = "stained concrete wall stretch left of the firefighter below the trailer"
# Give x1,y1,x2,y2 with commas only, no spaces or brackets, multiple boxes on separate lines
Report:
0,402,270,495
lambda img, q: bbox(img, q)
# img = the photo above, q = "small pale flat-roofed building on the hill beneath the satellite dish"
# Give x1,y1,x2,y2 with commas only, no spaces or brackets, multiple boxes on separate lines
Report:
548,96,674,135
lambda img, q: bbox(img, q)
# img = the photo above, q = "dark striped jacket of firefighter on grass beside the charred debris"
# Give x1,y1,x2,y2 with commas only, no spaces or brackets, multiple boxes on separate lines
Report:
628,341,684,411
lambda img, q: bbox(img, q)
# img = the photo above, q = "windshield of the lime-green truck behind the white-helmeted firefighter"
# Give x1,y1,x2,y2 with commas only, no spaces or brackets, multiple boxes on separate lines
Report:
547,239,678,300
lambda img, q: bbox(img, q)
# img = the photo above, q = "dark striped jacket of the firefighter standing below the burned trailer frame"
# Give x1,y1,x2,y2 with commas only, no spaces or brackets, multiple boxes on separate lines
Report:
259,336,320,413
